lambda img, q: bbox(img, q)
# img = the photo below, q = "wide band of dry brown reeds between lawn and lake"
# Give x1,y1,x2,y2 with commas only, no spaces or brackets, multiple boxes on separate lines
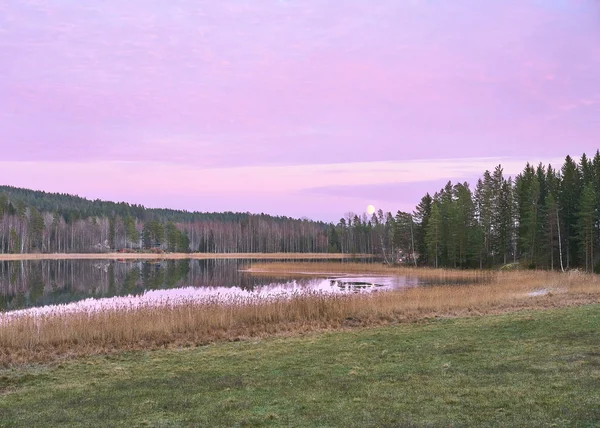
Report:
0,264,600,366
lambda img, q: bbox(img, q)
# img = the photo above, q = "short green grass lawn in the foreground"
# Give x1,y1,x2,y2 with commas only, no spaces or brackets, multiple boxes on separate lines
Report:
0,305,600,427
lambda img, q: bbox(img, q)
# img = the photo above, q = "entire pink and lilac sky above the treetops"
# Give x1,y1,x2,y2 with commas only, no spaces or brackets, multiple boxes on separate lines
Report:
0,0,600,221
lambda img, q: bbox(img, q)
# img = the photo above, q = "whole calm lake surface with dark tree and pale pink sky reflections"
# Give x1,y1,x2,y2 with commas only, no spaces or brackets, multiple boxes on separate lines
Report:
0,260,418,319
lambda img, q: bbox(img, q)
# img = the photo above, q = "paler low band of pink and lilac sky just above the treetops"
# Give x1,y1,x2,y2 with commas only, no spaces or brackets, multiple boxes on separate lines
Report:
0,158,563,220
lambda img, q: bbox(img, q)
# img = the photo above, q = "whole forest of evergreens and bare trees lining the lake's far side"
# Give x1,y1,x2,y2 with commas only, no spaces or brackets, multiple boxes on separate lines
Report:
0,151,600,271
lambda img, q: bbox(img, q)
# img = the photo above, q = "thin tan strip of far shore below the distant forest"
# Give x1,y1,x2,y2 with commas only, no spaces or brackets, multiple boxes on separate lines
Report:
0,253,373,261
